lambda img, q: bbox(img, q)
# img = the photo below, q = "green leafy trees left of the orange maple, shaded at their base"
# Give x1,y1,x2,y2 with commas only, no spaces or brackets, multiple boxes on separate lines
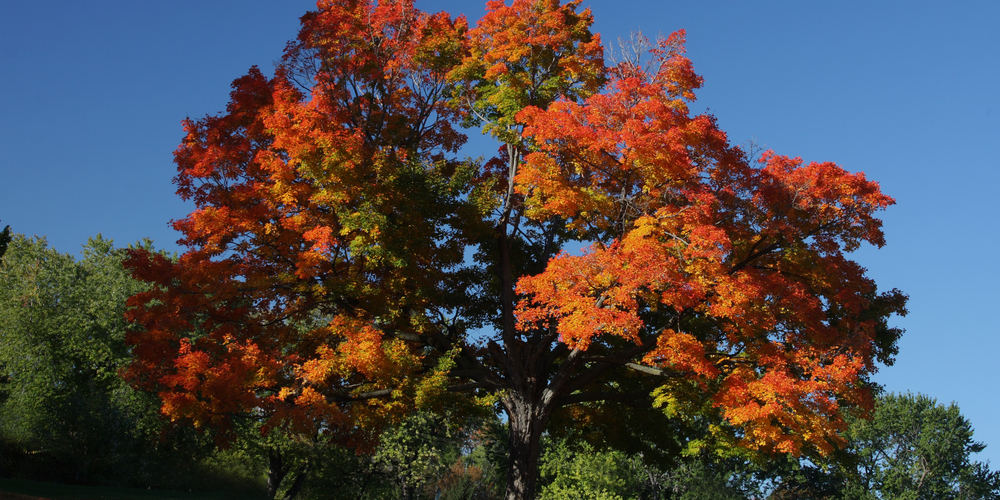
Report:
0,235,217,486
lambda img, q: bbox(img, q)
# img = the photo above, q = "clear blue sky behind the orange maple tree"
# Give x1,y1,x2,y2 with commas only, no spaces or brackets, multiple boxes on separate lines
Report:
0,0,1000,468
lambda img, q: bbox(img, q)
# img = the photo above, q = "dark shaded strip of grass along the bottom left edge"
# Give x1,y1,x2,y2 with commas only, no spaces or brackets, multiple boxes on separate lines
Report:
0,479,261,500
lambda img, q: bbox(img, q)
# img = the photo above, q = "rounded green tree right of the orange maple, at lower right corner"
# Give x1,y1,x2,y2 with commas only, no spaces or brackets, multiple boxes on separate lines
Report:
704,394,1000,500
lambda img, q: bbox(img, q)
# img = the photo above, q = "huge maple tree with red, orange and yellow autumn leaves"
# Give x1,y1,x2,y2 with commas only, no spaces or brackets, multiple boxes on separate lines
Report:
125,0,906,499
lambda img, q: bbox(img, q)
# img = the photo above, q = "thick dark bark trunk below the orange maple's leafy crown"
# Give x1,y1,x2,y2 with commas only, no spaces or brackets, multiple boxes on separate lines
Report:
504,396,550,500
